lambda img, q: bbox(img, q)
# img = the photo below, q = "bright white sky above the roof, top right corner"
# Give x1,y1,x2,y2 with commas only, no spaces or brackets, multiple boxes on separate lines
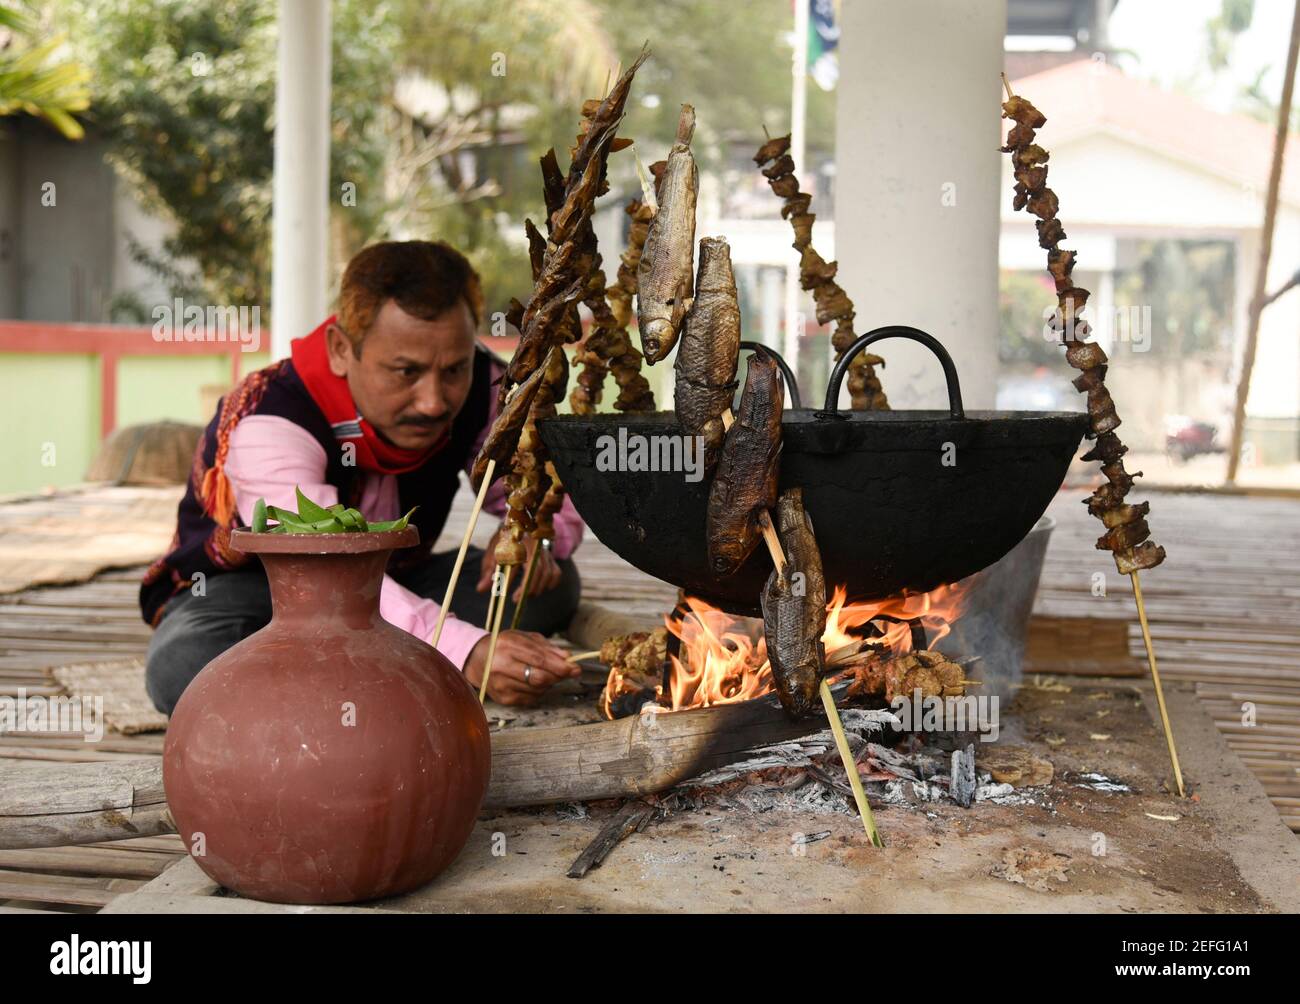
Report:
1110,0,1295,112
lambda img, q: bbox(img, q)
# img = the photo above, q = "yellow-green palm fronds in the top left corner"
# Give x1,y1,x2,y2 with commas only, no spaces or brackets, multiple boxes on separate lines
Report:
0,3,90,139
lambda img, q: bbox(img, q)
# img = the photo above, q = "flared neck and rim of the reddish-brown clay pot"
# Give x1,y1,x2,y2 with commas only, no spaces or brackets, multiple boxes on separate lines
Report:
230,527,420,629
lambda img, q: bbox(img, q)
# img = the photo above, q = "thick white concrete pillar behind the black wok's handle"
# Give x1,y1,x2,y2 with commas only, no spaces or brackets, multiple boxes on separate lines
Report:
832,0,1006,408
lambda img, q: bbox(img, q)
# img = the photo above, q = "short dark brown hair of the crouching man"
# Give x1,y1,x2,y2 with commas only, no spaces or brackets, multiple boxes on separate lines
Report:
338,241,484,354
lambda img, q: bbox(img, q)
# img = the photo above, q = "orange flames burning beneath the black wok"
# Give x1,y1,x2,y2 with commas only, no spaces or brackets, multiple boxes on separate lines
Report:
664,584,966,711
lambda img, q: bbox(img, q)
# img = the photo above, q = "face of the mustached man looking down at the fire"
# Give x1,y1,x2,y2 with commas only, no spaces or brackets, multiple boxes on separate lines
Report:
326,300,475,450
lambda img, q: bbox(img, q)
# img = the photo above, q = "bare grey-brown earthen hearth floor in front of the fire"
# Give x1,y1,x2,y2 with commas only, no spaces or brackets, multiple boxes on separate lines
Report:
374,678,1300,913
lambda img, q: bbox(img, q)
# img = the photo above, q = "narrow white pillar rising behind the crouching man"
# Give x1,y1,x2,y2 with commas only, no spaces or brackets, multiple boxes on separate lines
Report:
270,0,330,359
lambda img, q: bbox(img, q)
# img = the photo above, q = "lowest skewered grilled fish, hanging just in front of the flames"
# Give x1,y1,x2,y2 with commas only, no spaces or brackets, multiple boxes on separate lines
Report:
763,488,826,718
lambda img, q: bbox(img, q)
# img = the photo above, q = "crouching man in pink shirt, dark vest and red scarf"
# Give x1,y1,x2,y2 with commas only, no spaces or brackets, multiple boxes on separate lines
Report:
140,241,582,714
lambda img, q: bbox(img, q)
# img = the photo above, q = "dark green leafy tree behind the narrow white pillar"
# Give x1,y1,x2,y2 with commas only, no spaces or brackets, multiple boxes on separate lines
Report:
52,0,394,312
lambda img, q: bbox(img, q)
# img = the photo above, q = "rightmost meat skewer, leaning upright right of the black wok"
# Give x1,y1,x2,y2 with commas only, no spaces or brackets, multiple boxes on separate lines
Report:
1002,73,1186,797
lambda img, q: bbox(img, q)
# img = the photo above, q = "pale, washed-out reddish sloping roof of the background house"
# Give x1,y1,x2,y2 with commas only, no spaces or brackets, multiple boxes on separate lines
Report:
1004,60,1300,203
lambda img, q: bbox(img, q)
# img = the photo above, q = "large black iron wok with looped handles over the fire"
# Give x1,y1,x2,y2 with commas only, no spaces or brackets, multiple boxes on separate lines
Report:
541,326,1088,615
